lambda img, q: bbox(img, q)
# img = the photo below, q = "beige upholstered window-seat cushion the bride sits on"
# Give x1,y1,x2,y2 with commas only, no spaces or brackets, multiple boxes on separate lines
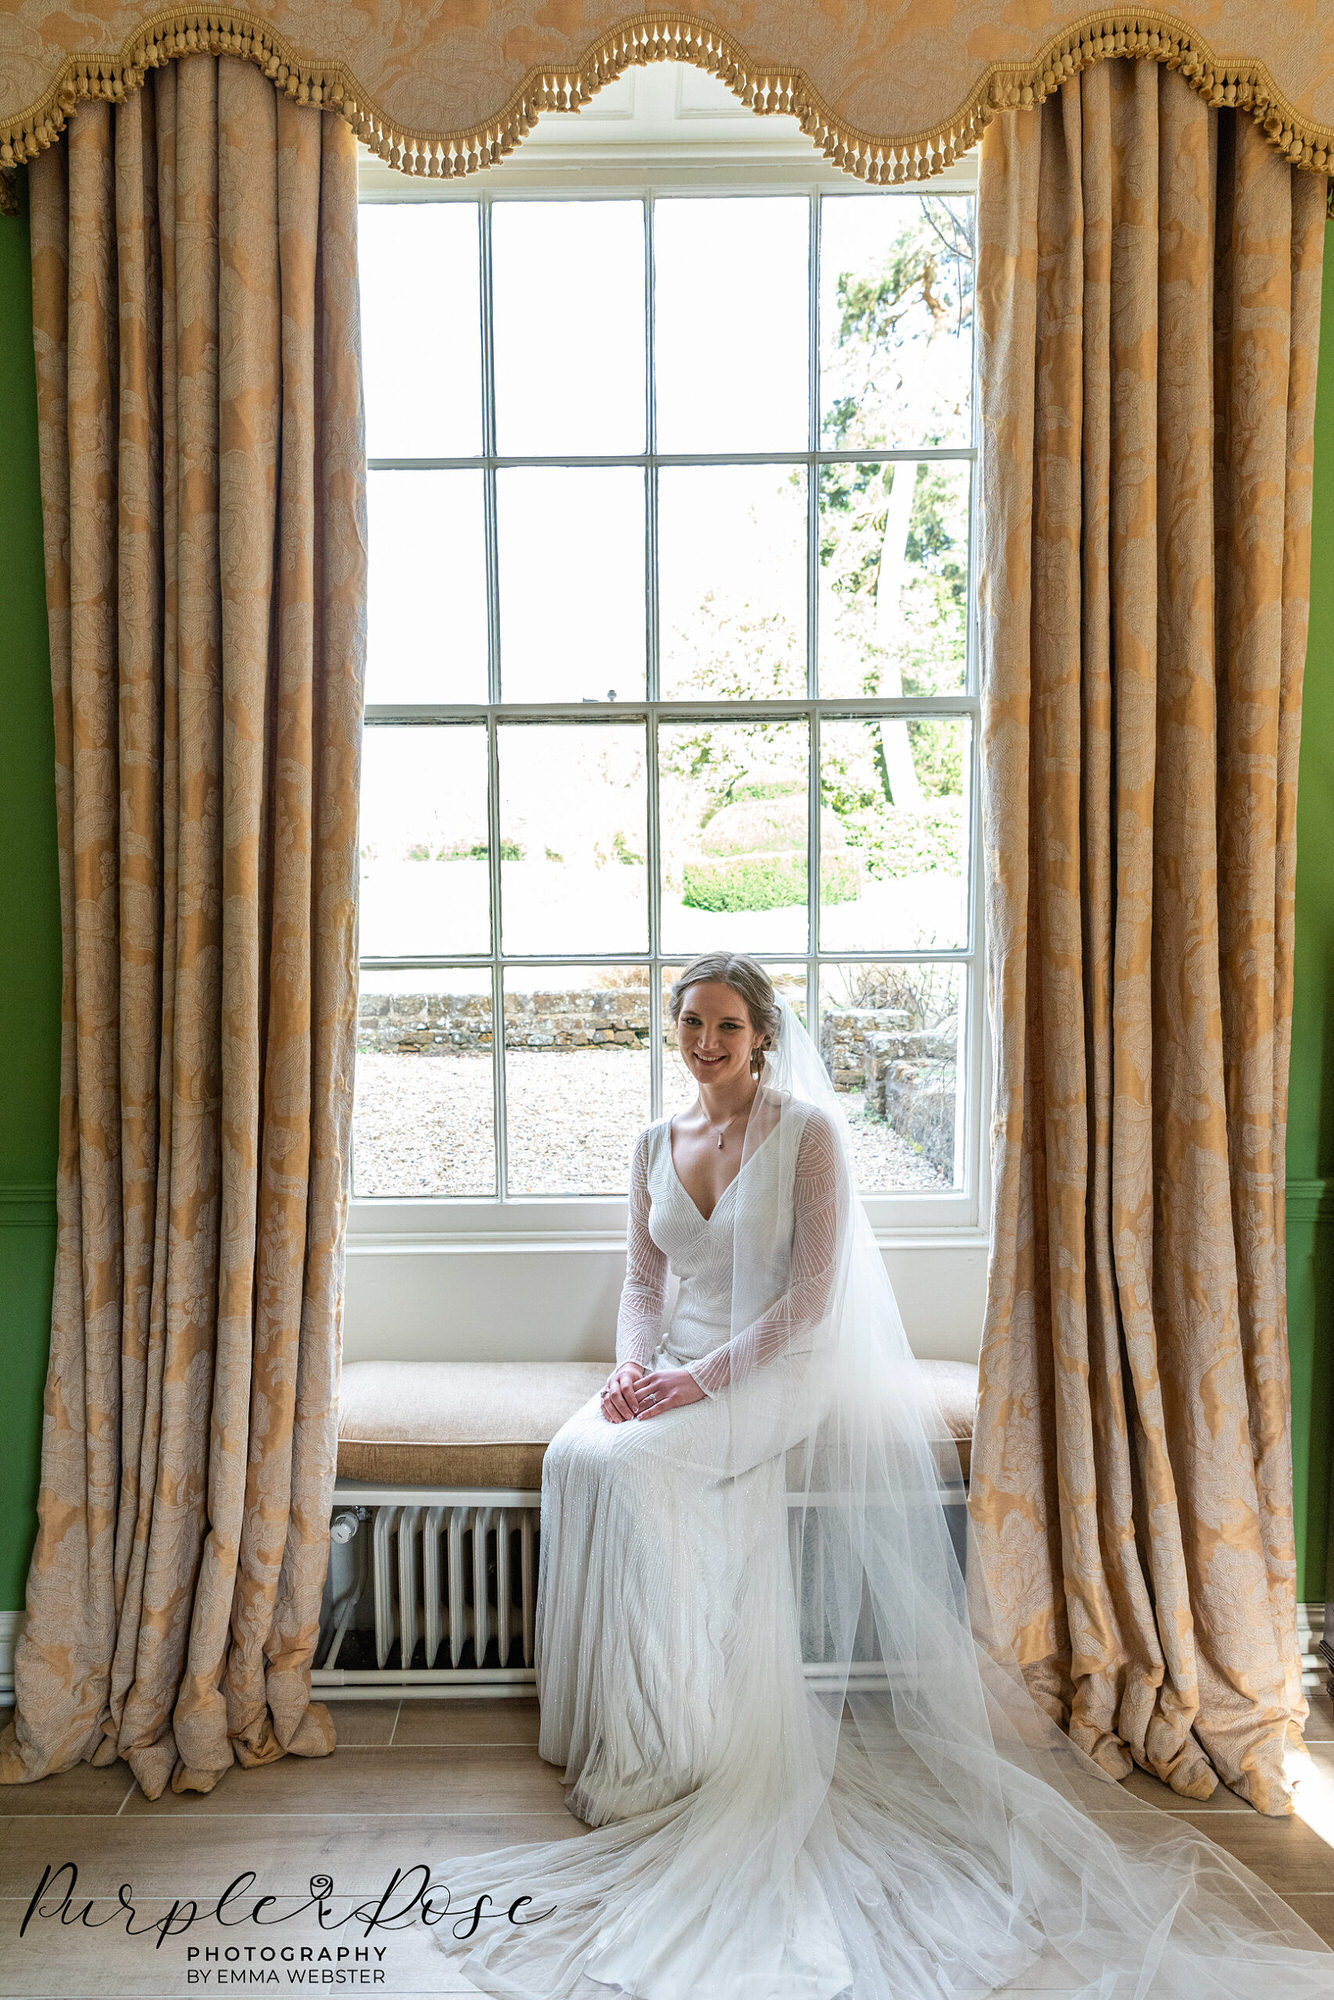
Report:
338,1362,978,1492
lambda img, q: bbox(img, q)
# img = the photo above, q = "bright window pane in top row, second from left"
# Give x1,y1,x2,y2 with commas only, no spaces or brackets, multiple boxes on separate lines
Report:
492,202,646,458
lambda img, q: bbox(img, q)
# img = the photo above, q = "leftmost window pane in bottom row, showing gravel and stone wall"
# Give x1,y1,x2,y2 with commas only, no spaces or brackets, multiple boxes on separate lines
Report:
352,966,496,1196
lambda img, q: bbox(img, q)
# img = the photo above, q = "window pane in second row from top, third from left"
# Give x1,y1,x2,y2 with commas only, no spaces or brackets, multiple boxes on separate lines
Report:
658,466,806,700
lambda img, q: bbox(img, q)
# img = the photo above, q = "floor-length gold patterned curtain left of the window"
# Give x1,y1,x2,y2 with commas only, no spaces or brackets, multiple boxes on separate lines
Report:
0,54,366,1798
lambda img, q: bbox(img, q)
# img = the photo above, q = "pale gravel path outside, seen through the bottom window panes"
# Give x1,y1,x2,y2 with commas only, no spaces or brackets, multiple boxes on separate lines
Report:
352,1048,944,1198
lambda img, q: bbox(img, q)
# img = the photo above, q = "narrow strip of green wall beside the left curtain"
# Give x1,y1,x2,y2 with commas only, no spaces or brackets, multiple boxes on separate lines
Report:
0,174,60,1610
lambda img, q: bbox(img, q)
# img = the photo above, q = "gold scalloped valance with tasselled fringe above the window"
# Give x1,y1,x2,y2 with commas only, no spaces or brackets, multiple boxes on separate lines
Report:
0,0,1334,182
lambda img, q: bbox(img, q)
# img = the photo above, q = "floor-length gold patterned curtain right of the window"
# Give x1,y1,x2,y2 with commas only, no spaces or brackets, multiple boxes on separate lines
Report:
972,62,1324,1812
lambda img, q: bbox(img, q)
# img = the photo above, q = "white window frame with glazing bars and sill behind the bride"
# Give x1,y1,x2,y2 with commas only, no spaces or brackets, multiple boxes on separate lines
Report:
348,108,990,1252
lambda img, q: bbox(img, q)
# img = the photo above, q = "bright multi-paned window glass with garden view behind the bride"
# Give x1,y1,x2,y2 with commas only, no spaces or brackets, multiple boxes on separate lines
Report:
354,86,982,1208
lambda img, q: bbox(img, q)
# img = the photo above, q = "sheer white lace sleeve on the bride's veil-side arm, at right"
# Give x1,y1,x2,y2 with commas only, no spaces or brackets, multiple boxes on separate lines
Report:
690,1112,852,1396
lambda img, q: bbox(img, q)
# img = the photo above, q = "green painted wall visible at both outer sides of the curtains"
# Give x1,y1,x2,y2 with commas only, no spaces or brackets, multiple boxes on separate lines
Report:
0,195,1334,1610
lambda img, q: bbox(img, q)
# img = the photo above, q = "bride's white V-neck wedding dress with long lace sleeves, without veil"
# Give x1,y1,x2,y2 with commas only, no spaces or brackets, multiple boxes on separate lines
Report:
536,1114,834,1826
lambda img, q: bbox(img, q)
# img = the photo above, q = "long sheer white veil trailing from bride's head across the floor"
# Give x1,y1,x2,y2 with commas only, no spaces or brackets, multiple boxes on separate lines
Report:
434,1002,1334,2000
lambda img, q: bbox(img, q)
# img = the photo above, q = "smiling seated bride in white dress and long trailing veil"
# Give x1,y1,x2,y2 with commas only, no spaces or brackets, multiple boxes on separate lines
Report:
432,952,1334,2000
